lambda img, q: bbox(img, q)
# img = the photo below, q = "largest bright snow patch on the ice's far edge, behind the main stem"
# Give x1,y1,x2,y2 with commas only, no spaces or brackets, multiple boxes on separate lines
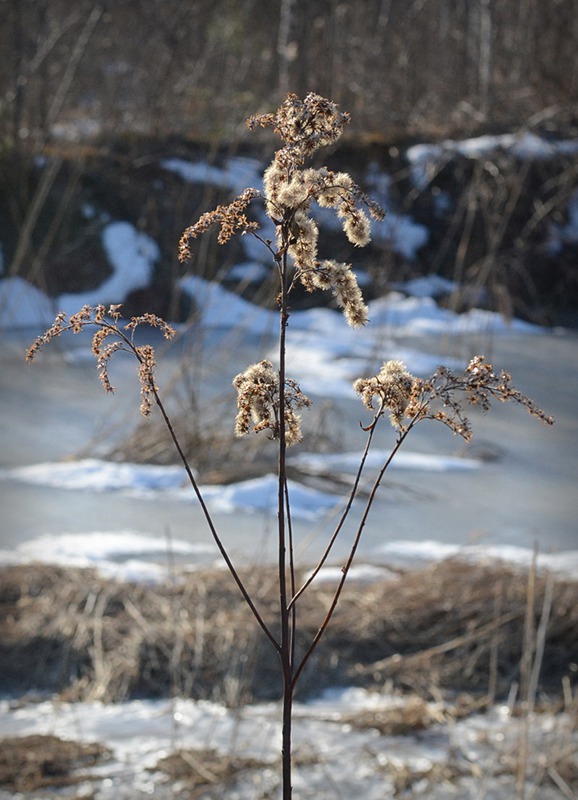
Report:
181,276,541,398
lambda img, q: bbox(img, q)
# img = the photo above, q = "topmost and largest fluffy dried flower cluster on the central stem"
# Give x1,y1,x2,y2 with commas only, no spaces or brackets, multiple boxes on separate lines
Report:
179,94,384,327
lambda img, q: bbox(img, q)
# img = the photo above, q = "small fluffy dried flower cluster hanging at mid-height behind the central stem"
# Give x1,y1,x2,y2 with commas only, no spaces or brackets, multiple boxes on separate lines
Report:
233,361,310,447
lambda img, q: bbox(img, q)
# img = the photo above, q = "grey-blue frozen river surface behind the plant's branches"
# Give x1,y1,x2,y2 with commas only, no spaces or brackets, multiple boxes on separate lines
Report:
0,318,578,561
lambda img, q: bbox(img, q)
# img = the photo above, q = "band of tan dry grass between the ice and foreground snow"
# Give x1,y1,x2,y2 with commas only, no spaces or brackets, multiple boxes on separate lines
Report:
0,560,578,706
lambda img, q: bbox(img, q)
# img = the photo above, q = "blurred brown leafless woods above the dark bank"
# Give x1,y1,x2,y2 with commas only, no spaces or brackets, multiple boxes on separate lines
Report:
1,0,578,142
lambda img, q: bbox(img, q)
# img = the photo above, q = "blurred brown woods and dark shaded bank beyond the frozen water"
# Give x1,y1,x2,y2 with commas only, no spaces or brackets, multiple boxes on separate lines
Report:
0,0,578,324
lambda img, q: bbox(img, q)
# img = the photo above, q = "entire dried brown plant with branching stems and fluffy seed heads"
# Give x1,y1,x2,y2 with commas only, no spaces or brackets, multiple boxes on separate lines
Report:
27,94,553,800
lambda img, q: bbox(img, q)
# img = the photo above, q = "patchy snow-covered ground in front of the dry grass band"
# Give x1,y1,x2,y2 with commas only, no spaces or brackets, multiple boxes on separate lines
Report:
0,689,578,800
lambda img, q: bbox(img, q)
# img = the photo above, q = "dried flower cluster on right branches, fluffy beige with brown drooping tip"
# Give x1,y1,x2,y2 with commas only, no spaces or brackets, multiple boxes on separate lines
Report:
354,356,554,441
